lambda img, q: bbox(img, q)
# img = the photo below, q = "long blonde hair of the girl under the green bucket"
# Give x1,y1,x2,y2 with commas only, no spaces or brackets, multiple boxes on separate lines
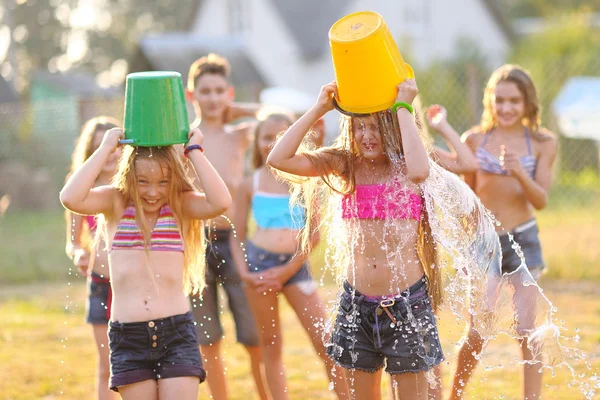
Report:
99,146,206,294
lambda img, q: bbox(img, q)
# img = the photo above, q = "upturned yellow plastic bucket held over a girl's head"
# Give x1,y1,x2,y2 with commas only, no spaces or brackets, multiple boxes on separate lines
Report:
329,11,415,114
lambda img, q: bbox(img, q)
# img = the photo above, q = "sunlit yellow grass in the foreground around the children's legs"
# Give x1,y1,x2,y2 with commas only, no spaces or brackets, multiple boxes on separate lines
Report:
0,281,600,400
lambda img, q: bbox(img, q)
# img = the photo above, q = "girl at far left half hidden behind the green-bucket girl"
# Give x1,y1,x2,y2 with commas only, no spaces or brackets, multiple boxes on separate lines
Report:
65,116,121,400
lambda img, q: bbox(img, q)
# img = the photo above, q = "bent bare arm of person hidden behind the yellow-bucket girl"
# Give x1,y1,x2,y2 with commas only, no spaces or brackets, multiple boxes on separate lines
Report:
426,104,477,174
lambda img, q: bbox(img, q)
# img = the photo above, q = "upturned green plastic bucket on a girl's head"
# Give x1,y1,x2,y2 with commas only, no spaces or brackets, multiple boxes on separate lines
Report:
120,71,190,147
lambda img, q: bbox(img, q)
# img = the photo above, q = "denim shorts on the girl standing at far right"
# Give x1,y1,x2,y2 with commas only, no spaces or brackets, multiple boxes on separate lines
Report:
496,219,546,280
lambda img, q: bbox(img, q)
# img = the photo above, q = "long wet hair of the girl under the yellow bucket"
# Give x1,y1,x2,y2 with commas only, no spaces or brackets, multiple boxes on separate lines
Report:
280,110,442,308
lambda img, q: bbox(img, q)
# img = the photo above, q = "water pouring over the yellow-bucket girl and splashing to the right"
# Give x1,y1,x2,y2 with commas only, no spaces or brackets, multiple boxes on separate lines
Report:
282,112,600,399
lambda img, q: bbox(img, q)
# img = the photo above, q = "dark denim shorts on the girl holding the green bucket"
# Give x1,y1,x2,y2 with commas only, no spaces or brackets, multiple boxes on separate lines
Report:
108,312,206,392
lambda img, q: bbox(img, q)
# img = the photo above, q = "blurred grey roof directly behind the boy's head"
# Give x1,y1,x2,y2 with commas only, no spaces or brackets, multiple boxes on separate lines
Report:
130,32,266,85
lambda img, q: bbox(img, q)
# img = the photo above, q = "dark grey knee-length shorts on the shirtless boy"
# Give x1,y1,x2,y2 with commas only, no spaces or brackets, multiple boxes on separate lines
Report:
191,229,259,347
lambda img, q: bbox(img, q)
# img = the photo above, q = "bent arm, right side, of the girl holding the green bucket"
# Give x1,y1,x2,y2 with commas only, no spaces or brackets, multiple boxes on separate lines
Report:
183,128,231,219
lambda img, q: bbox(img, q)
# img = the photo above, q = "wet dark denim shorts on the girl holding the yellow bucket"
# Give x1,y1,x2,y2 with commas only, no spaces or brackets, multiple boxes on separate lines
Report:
327,277,444,374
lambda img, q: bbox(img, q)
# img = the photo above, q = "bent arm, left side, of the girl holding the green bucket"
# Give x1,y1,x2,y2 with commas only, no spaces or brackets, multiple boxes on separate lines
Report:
60,128,124,215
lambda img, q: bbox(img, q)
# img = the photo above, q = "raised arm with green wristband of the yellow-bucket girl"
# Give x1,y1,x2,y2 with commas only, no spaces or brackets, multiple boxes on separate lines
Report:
396,79,429,183
